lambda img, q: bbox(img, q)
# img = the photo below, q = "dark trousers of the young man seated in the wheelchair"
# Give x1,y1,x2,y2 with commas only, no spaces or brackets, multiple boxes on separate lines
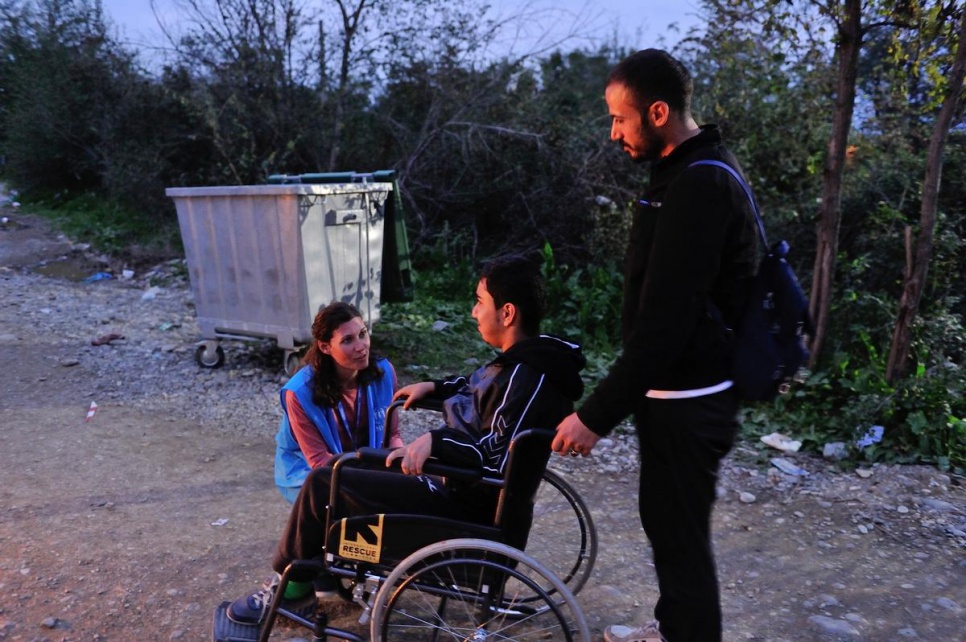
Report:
272,467,471,581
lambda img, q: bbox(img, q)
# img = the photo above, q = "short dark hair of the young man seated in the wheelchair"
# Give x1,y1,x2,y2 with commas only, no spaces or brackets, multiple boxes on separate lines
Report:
480,255,547,335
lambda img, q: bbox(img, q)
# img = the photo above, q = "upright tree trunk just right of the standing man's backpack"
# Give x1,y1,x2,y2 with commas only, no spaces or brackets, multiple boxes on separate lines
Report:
809,0,862,368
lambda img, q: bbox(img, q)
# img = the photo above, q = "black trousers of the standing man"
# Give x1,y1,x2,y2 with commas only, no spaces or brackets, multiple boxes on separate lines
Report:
635,390,739,642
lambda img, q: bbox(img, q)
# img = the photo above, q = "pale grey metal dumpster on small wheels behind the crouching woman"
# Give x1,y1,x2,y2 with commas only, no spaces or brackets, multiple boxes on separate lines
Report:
165,183,392,374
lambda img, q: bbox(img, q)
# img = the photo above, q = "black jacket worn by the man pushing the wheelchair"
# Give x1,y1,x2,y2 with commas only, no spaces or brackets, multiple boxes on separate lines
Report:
577,125,758,435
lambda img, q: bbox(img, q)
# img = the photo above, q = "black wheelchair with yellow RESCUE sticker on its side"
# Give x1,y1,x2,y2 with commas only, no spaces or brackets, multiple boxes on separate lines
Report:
212,402,596,642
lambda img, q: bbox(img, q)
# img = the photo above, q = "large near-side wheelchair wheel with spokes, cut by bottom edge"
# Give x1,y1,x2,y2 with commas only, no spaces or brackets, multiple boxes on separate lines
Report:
370,539,590,642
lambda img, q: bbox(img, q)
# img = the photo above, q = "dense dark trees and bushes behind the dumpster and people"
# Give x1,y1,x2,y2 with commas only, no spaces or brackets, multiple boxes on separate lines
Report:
0,0,966,471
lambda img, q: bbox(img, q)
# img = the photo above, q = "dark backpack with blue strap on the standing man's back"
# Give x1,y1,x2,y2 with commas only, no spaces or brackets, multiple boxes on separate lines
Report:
688,160,812,401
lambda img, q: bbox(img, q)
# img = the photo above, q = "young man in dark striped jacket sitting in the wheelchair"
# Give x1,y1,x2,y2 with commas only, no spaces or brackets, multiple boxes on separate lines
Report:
228,252,585,625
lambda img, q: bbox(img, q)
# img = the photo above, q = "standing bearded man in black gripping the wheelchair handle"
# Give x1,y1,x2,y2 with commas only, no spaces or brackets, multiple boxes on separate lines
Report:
553,49,757,642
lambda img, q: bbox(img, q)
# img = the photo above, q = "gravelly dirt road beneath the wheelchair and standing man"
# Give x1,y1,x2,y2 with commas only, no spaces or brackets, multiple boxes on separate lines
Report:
0,215,966,642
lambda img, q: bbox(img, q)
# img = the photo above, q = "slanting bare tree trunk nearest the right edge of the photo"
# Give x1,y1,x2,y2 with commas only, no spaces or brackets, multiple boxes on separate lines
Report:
885,10,966,383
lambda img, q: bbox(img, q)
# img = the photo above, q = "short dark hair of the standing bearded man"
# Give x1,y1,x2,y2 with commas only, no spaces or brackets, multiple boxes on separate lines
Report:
606,49,694,115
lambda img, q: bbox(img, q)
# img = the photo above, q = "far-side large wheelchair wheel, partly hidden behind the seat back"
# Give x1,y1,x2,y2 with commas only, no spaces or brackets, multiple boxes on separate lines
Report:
526,470,597,595
